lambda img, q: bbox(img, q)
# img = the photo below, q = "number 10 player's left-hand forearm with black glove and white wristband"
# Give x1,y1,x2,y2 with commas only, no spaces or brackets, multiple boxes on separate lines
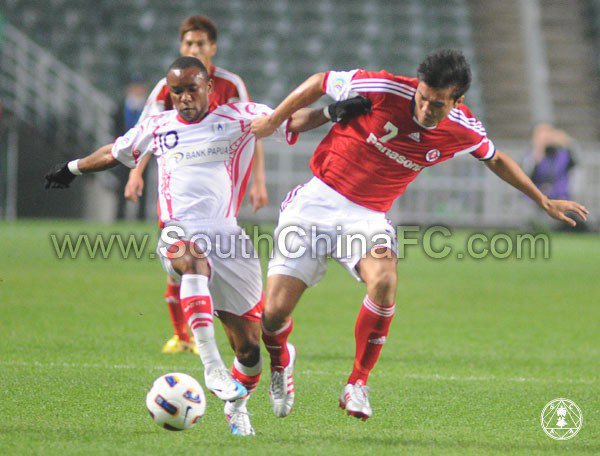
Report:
45,144,119,188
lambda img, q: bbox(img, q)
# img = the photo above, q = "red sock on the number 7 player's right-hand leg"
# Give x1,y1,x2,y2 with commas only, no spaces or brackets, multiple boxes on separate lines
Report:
348,295,396,385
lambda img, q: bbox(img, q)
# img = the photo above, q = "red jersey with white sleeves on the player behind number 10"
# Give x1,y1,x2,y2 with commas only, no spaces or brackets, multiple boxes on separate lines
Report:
137,65,250,125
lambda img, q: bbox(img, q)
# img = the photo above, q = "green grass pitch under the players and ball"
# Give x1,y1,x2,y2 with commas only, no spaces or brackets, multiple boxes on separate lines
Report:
0,221,600,455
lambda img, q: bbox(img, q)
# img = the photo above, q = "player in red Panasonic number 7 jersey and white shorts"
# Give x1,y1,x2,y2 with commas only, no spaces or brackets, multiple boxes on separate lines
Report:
252,50,588,419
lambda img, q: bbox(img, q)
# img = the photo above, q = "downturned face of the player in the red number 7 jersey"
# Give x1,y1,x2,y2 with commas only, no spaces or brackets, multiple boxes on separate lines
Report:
414,81,464,127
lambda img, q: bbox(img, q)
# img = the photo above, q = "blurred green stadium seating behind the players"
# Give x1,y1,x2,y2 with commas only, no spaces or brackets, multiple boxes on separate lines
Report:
3,0,482,112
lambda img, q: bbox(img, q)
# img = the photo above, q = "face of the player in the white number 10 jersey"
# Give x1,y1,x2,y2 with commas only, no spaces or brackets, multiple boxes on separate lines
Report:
167,67,212,122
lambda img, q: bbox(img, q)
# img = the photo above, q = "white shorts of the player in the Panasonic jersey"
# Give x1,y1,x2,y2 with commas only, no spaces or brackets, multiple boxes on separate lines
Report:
268,177,397,286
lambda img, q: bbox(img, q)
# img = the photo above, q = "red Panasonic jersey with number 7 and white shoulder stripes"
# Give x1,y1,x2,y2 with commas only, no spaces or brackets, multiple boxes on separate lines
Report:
310,70,495,212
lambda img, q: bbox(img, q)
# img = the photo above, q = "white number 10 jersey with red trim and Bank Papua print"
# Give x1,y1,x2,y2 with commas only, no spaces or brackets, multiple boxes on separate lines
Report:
112,102,272,223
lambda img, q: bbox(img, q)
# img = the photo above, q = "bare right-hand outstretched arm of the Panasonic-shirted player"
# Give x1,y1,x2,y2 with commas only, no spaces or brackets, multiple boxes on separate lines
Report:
485,150,589,226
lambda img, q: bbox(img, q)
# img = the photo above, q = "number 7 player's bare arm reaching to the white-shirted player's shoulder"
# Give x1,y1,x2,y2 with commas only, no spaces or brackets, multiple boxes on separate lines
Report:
251,73,327,138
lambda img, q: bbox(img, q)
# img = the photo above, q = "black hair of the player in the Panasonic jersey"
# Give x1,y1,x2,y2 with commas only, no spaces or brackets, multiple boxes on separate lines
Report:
417,49,471,100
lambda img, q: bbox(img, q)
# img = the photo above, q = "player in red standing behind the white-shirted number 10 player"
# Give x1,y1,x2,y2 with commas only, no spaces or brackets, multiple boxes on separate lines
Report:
125,16,268,353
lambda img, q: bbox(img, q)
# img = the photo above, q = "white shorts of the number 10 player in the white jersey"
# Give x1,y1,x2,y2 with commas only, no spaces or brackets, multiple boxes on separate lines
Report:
156,219,262,317
